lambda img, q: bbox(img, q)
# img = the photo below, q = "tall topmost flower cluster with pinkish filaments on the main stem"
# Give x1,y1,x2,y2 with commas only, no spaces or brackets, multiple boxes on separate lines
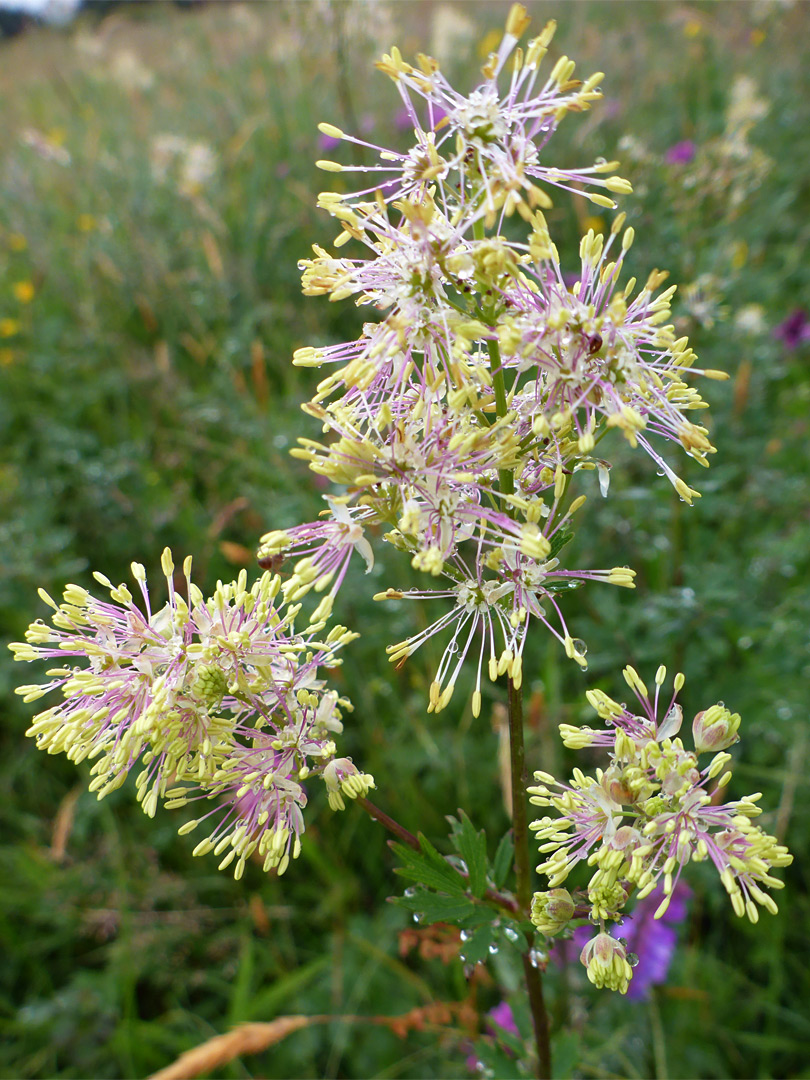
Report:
259,4,725,714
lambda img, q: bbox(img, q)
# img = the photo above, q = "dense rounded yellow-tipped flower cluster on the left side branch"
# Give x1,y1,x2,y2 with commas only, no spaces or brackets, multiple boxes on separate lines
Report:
11,549,374,878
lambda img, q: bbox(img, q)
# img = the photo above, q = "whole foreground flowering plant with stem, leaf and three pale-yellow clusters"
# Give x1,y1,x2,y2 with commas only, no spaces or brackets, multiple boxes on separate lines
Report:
15,4,789,1077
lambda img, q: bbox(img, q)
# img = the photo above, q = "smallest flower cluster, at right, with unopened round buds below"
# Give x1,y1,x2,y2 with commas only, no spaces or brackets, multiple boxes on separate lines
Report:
528,666,793,994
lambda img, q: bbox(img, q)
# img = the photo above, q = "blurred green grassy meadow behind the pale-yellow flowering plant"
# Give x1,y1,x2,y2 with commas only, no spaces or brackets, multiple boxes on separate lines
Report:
0,0,810,1078
